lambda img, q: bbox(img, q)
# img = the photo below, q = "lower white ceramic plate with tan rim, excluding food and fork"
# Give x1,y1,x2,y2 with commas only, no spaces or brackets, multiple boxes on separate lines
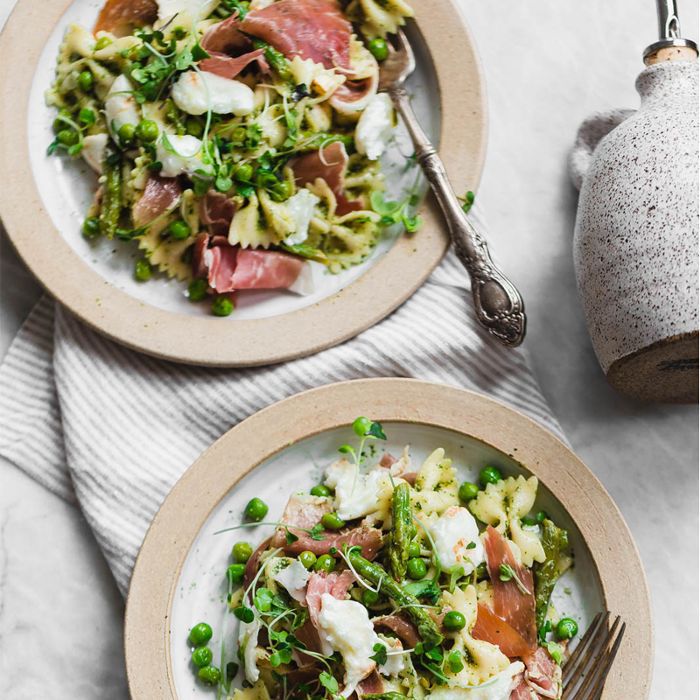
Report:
125,379,652,700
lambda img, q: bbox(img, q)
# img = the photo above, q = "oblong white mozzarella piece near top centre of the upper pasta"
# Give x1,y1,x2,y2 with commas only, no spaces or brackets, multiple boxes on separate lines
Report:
171,70,254,117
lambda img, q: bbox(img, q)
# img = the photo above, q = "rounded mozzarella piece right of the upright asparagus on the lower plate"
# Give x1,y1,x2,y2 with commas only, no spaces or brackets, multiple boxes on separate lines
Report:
430,506,484,575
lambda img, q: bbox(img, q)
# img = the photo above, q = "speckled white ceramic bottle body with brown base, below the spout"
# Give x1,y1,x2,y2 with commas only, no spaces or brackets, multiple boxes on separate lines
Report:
572,53,698,402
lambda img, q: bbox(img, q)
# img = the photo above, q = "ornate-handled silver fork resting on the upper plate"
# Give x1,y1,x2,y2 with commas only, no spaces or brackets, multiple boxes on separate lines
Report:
379,31,525,347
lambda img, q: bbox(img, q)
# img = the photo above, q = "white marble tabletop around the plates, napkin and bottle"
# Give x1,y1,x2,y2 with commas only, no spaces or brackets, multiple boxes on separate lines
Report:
0,0,698,700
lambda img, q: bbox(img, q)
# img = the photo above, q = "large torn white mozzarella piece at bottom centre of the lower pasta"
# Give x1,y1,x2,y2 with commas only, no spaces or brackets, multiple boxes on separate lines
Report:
318,593,379,697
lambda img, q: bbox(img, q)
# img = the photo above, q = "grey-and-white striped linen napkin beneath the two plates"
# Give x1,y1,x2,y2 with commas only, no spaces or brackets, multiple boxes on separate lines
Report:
0,211,561,594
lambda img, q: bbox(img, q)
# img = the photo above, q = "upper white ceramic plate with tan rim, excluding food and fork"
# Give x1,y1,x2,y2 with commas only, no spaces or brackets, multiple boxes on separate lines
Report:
0,0,486,366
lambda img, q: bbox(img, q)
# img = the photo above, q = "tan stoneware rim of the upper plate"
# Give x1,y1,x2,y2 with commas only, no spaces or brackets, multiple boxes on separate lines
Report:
0,0,486,367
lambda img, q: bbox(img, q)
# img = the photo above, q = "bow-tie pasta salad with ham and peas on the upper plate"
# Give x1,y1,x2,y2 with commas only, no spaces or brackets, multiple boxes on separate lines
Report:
47,0,418,316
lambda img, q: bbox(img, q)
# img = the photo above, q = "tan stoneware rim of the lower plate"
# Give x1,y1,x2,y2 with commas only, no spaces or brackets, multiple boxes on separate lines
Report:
124,379,653,700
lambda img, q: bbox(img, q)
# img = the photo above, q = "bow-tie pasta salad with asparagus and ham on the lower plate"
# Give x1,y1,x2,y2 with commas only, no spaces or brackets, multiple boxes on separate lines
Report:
188,417,578,700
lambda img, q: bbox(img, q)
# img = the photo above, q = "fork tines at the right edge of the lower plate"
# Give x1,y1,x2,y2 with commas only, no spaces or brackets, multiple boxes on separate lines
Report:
562,612,627,700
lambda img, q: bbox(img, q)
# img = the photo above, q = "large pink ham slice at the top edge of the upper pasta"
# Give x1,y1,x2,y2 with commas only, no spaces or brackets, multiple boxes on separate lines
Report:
239,0,352,68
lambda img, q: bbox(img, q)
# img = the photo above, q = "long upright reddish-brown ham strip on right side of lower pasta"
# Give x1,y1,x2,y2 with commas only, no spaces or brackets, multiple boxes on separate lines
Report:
484,526,537,650
